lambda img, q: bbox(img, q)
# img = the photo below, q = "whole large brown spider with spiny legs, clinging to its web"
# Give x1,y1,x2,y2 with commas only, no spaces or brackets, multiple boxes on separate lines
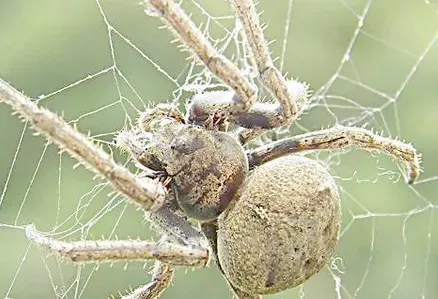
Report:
0,0,420,298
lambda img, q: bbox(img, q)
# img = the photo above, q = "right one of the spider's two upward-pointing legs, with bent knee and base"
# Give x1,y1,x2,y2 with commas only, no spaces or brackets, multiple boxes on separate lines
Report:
188,0,309,129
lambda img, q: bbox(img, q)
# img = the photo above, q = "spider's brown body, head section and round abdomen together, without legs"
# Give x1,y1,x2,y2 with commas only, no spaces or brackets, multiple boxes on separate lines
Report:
122,99,340,294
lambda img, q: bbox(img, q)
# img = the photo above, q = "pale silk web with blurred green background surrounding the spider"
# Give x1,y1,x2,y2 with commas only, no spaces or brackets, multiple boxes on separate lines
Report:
0,0,438,299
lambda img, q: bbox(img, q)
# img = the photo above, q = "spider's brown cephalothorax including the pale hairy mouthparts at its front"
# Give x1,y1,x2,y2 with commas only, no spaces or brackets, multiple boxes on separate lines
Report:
118,104,248,221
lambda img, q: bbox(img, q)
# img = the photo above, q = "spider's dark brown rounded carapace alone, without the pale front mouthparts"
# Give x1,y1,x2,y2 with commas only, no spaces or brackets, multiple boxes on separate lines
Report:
166,125,248,221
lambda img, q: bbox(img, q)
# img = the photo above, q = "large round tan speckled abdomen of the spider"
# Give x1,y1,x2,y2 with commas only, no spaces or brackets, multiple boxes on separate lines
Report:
218,155,340,294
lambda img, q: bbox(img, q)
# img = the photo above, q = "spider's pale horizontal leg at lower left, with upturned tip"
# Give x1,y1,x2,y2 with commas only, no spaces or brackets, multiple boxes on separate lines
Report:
26,225,209,267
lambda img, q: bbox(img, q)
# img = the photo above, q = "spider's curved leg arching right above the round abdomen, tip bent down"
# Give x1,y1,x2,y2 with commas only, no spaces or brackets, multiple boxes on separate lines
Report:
247,127,420,184
